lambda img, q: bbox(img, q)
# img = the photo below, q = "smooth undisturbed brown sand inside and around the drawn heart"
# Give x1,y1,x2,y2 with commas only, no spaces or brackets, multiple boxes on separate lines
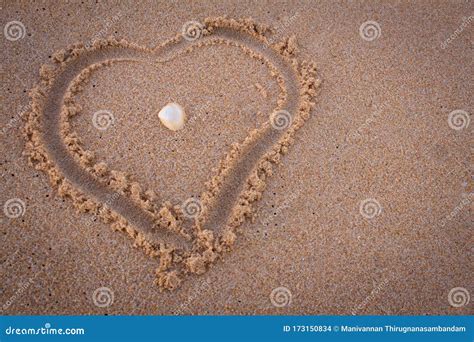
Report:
0,2,474,314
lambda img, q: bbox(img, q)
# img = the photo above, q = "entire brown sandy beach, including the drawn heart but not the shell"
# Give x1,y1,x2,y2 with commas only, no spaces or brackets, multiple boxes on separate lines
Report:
1,2,473,314
